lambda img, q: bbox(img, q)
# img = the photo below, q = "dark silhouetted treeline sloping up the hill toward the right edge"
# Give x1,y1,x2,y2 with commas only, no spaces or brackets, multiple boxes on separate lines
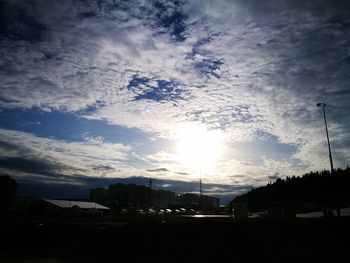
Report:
230,167,350,211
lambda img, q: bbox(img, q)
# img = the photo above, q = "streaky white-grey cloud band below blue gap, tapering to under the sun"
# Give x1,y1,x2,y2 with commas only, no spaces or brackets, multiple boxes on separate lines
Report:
0,129,205,187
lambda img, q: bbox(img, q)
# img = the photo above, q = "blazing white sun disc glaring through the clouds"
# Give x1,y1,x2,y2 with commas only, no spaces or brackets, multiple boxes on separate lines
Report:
177,125,222,174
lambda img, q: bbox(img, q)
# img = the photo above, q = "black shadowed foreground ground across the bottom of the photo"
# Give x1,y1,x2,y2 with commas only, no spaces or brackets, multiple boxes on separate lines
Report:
0,217,350,263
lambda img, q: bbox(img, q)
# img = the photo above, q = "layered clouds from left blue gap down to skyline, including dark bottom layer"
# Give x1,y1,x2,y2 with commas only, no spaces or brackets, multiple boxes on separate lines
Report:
0,129,252,202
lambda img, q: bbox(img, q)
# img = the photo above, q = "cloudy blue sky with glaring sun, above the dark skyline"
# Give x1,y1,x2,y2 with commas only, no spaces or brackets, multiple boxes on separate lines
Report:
0,0,350,204
